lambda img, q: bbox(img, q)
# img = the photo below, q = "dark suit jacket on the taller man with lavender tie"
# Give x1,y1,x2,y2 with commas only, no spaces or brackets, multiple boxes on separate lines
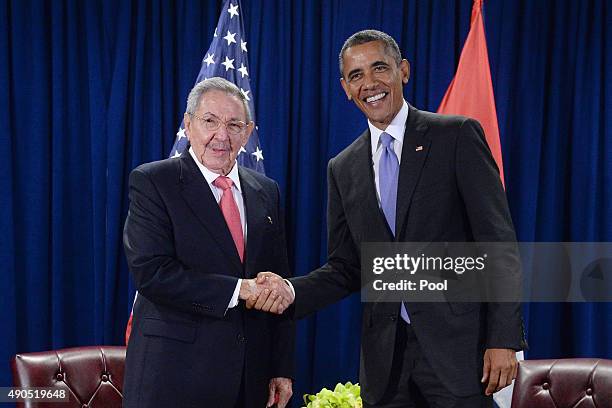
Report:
291,107,523,404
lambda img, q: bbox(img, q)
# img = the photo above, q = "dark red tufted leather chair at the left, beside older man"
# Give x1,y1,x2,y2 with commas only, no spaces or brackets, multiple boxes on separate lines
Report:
12,346,125,408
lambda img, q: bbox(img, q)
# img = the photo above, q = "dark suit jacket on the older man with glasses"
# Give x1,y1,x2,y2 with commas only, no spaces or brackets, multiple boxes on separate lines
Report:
123,152,294,408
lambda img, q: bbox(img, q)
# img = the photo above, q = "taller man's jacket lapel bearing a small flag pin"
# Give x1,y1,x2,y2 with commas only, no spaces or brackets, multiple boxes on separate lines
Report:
395,105,430,240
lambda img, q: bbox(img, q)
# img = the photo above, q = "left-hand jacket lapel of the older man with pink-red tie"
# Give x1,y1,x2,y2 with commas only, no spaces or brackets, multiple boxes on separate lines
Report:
178,150,242,276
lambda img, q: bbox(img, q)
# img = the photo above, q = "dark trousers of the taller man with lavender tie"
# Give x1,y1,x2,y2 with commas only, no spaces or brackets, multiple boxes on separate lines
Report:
363,319,493,408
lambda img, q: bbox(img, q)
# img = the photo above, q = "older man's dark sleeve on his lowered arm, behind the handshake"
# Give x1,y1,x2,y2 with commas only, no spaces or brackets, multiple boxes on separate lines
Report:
272,183,295,378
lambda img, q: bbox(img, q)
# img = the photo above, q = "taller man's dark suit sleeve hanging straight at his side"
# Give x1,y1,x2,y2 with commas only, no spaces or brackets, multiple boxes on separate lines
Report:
456,119,526,350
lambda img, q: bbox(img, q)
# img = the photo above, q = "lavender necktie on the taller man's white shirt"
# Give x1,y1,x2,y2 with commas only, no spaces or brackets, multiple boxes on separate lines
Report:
378,132,410,323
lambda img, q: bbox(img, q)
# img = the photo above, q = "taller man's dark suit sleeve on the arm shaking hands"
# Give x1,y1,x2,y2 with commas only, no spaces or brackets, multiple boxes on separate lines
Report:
291,159,361,319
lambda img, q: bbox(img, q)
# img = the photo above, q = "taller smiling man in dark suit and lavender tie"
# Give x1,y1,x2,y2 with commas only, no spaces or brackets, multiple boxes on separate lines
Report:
248,30,524,408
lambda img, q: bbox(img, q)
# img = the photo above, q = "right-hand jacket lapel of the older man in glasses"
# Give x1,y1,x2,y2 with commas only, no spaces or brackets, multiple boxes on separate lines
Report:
238,167,270,278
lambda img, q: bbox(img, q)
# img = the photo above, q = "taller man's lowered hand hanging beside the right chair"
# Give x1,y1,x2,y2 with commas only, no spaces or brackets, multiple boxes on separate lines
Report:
480,349,518,395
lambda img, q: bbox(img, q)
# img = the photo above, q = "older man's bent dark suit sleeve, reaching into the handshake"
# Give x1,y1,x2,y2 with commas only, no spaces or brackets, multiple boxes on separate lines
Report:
123,168,238,318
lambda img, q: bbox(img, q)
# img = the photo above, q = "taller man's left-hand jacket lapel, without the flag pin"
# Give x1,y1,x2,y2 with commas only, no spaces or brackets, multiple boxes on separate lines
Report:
349,129,392,242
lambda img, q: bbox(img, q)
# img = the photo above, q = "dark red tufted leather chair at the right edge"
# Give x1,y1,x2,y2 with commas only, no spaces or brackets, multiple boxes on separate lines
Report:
512,358,612,408
